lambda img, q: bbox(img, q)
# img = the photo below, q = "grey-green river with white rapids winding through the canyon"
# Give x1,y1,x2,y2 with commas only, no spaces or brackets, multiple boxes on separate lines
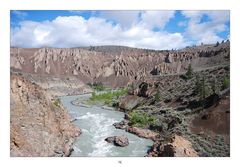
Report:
60,94,153,157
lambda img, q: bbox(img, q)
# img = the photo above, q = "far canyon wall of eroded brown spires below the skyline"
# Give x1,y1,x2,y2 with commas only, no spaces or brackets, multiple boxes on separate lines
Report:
11,42,230,87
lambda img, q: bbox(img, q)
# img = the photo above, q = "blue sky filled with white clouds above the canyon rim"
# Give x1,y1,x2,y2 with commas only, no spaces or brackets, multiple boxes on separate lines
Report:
10,10,230,50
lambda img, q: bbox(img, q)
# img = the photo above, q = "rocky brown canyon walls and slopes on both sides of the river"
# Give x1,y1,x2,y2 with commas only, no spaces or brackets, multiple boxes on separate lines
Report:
10,41,230,156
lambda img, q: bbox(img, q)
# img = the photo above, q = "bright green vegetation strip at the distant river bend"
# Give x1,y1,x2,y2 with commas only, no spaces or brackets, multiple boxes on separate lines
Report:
88,89,128,106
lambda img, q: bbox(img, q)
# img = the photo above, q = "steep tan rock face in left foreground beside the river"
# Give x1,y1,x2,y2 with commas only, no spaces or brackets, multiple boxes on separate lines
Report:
10,74,80,156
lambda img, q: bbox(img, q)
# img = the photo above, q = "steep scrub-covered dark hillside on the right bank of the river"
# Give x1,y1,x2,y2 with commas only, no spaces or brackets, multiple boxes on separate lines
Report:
117,66,230,156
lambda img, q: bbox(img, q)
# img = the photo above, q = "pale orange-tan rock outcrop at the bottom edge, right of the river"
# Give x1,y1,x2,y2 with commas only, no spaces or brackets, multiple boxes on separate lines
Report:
148,135,198,157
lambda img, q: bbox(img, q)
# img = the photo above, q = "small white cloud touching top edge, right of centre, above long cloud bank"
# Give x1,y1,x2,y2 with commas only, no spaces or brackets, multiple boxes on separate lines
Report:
140,10,175,29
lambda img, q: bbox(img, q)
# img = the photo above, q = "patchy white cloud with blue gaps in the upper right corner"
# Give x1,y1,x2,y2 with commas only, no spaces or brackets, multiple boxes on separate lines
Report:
182,11,229,44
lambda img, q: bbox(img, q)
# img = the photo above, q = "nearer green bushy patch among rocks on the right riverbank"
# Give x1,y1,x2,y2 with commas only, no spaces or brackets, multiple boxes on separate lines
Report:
129,111,156,127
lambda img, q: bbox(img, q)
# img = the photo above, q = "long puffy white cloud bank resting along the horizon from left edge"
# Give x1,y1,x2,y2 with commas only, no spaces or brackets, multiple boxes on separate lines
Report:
11,16,189,49
